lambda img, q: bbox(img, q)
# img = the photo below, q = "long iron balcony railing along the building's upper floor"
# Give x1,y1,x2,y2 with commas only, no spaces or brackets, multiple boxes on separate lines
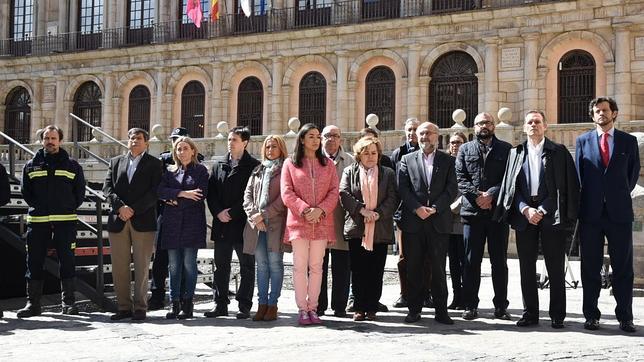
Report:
0,0,572,57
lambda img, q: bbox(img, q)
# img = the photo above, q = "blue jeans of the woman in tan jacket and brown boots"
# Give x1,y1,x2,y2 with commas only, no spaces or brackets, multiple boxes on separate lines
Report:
255,231,284,305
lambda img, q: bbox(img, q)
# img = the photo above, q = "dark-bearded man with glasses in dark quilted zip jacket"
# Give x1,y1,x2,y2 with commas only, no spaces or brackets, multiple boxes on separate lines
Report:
456,113,512,320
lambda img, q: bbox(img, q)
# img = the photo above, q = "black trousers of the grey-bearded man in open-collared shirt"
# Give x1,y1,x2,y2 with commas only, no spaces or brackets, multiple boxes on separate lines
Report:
403,225,449,313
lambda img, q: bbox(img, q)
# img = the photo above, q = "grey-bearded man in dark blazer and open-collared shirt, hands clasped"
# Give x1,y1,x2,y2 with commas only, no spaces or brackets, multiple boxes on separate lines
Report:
397,122,457,324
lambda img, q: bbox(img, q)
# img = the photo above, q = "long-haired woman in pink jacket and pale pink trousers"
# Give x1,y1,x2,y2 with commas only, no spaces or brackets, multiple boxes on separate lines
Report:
281,123,339,325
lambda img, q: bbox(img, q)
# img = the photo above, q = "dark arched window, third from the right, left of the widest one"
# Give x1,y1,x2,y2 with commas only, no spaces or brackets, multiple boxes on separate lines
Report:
365,66,396,131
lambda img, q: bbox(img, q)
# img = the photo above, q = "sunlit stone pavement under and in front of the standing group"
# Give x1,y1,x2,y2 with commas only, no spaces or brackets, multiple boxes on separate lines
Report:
0,256,644,361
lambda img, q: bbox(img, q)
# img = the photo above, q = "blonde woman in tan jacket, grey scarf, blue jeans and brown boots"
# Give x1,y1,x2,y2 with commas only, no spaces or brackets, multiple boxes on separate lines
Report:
243,135,288,321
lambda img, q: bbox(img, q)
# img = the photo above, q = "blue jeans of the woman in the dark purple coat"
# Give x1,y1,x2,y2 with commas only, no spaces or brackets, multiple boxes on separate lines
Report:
168,248,199,302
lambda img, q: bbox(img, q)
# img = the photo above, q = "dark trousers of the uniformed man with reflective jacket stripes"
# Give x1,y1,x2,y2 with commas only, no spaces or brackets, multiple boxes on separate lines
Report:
25,221,76,280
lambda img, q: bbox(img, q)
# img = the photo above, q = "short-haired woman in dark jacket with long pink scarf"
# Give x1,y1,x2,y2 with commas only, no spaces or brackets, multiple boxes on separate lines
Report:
340,137,399,321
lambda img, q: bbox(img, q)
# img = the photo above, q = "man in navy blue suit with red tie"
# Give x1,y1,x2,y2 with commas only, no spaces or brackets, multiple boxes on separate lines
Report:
575,97,640,333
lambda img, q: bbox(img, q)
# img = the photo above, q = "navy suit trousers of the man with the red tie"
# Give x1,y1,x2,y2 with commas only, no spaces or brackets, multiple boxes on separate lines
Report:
579,208,634,321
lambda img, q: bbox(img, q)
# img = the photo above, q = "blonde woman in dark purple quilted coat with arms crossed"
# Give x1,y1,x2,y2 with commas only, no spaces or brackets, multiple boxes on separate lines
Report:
159,137,208,319
